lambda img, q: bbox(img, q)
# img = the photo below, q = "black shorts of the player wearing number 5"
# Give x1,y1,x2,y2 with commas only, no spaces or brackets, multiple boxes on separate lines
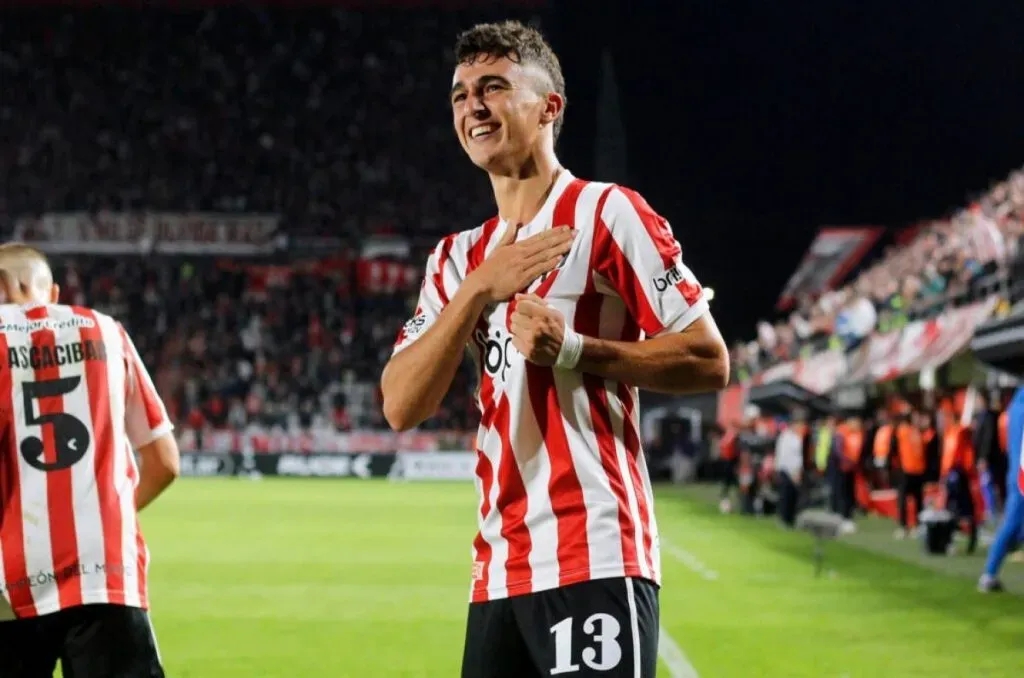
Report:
0,604,164,678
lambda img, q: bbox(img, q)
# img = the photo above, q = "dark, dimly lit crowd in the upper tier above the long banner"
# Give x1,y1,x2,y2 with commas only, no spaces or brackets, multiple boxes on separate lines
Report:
0,8,544,242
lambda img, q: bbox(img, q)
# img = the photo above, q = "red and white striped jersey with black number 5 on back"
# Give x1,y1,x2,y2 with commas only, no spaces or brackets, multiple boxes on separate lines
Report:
0,304,171,618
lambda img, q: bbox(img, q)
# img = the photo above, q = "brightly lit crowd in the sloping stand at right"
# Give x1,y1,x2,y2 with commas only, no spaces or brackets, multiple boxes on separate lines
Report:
732,169,1024,377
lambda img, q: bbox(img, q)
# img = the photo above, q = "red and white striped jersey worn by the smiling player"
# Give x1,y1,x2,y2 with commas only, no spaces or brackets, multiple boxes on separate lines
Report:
394,171,708,601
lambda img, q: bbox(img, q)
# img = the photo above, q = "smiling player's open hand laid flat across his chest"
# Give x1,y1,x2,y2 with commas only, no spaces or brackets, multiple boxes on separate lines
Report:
466,225,575,303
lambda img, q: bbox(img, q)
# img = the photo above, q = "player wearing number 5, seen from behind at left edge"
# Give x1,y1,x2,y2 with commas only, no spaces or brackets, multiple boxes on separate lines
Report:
0,244,178,678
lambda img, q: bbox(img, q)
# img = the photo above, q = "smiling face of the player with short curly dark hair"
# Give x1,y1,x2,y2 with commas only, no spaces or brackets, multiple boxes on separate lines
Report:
452,56,561,173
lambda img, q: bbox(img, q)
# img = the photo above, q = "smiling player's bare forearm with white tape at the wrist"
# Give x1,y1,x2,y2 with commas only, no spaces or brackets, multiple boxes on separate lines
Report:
577,333,729,395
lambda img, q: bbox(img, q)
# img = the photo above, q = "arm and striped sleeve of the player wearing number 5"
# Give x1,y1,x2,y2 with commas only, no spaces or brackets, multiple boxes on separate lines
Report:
121,328,181,511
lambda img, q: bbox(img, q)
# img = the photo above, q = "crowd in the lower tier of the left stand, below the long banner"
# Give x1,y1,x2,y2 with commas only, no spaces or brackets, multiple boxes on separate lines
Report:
48,256,475,431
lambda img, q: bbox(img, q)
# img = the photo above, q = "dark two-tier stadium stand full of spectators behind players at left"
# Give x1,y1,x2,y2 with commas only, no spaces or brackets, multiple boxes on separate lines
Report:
0,7,552,440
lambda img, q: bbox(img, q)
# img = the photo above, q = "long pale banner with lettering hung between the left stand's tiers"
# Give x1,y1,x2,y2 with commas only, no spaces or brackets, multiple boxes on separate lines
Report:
13,212,280,256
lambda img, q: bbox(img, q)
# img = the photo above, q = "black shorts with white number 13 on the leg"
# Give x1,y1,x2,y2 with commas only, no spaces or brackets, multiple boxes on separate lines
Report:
462,578,658,678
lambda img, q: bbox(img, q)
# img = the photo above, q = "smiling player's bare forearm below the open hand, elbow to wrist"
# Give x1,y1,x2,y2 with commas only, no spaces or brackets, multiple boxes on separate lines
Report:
381,285,486,431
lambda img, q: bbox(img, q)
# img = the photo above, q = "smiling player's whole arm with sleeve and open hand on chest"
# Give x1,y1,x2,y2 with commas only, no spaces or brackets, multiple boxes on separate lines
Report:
381,226,572,431
